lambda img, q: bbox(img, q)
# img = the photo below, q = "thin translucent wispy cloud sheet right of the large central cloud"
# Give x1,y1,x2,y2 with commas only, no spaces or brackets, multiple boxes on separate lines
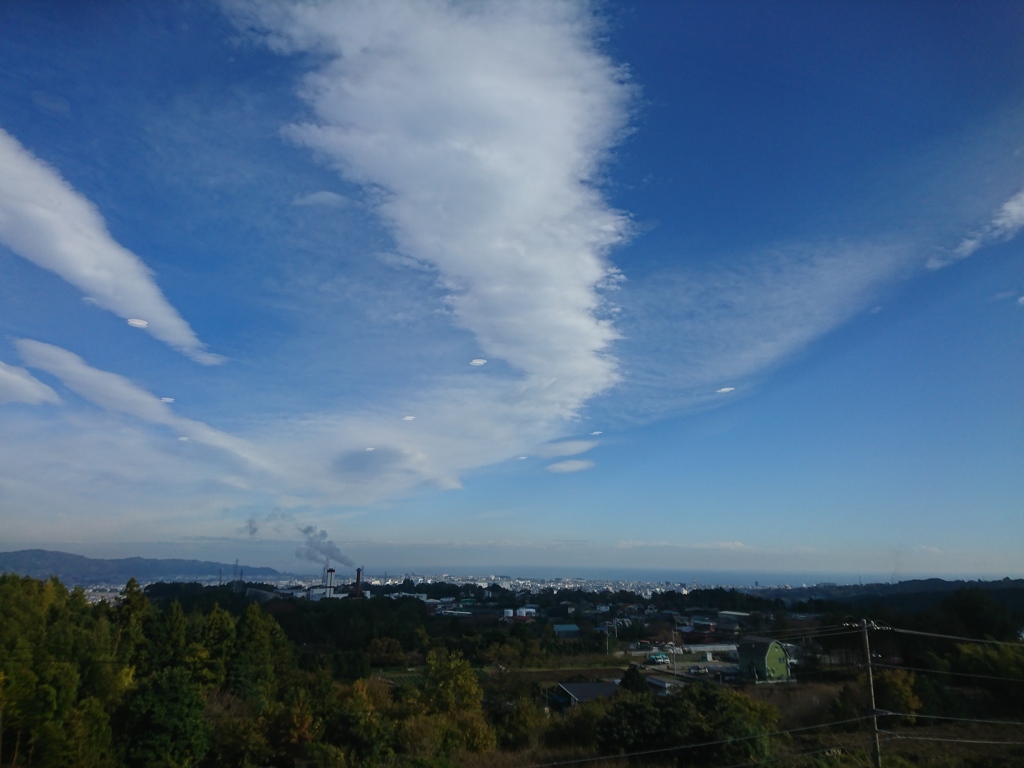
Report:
618,244,914,419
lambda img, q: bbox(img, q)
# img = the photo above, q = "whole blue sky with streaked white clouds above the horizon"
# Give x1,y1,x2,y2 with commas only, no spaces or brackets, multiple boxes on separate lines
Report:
0,0,1024,578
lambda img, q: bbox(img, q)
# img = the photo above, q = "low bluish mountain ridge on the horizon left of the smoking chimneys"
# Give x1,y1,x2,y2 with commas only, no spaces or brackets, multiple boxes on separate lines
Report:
0,549,284,587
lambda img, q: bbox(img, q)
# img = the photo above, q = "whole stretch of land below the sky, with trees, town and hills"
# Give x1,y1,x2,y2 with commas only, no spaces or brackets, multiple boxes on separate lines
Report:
0,550,1024,768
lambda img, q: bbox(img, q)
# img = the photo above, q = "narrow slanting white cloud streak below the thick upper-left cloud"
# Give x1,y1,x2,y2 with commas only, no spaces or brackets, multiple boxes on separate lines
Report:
15,339,265,467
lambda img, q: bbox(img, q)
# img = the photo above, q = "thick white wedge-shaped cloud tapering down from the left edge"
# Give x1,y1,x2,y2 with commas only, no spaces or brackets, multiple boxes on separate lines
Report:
0,129,222,365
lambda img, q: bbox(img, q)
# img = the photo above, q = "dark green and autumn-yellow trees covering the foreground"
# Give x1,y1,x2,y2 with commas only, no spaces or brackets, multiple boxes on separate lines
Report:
0,573,1024,768
